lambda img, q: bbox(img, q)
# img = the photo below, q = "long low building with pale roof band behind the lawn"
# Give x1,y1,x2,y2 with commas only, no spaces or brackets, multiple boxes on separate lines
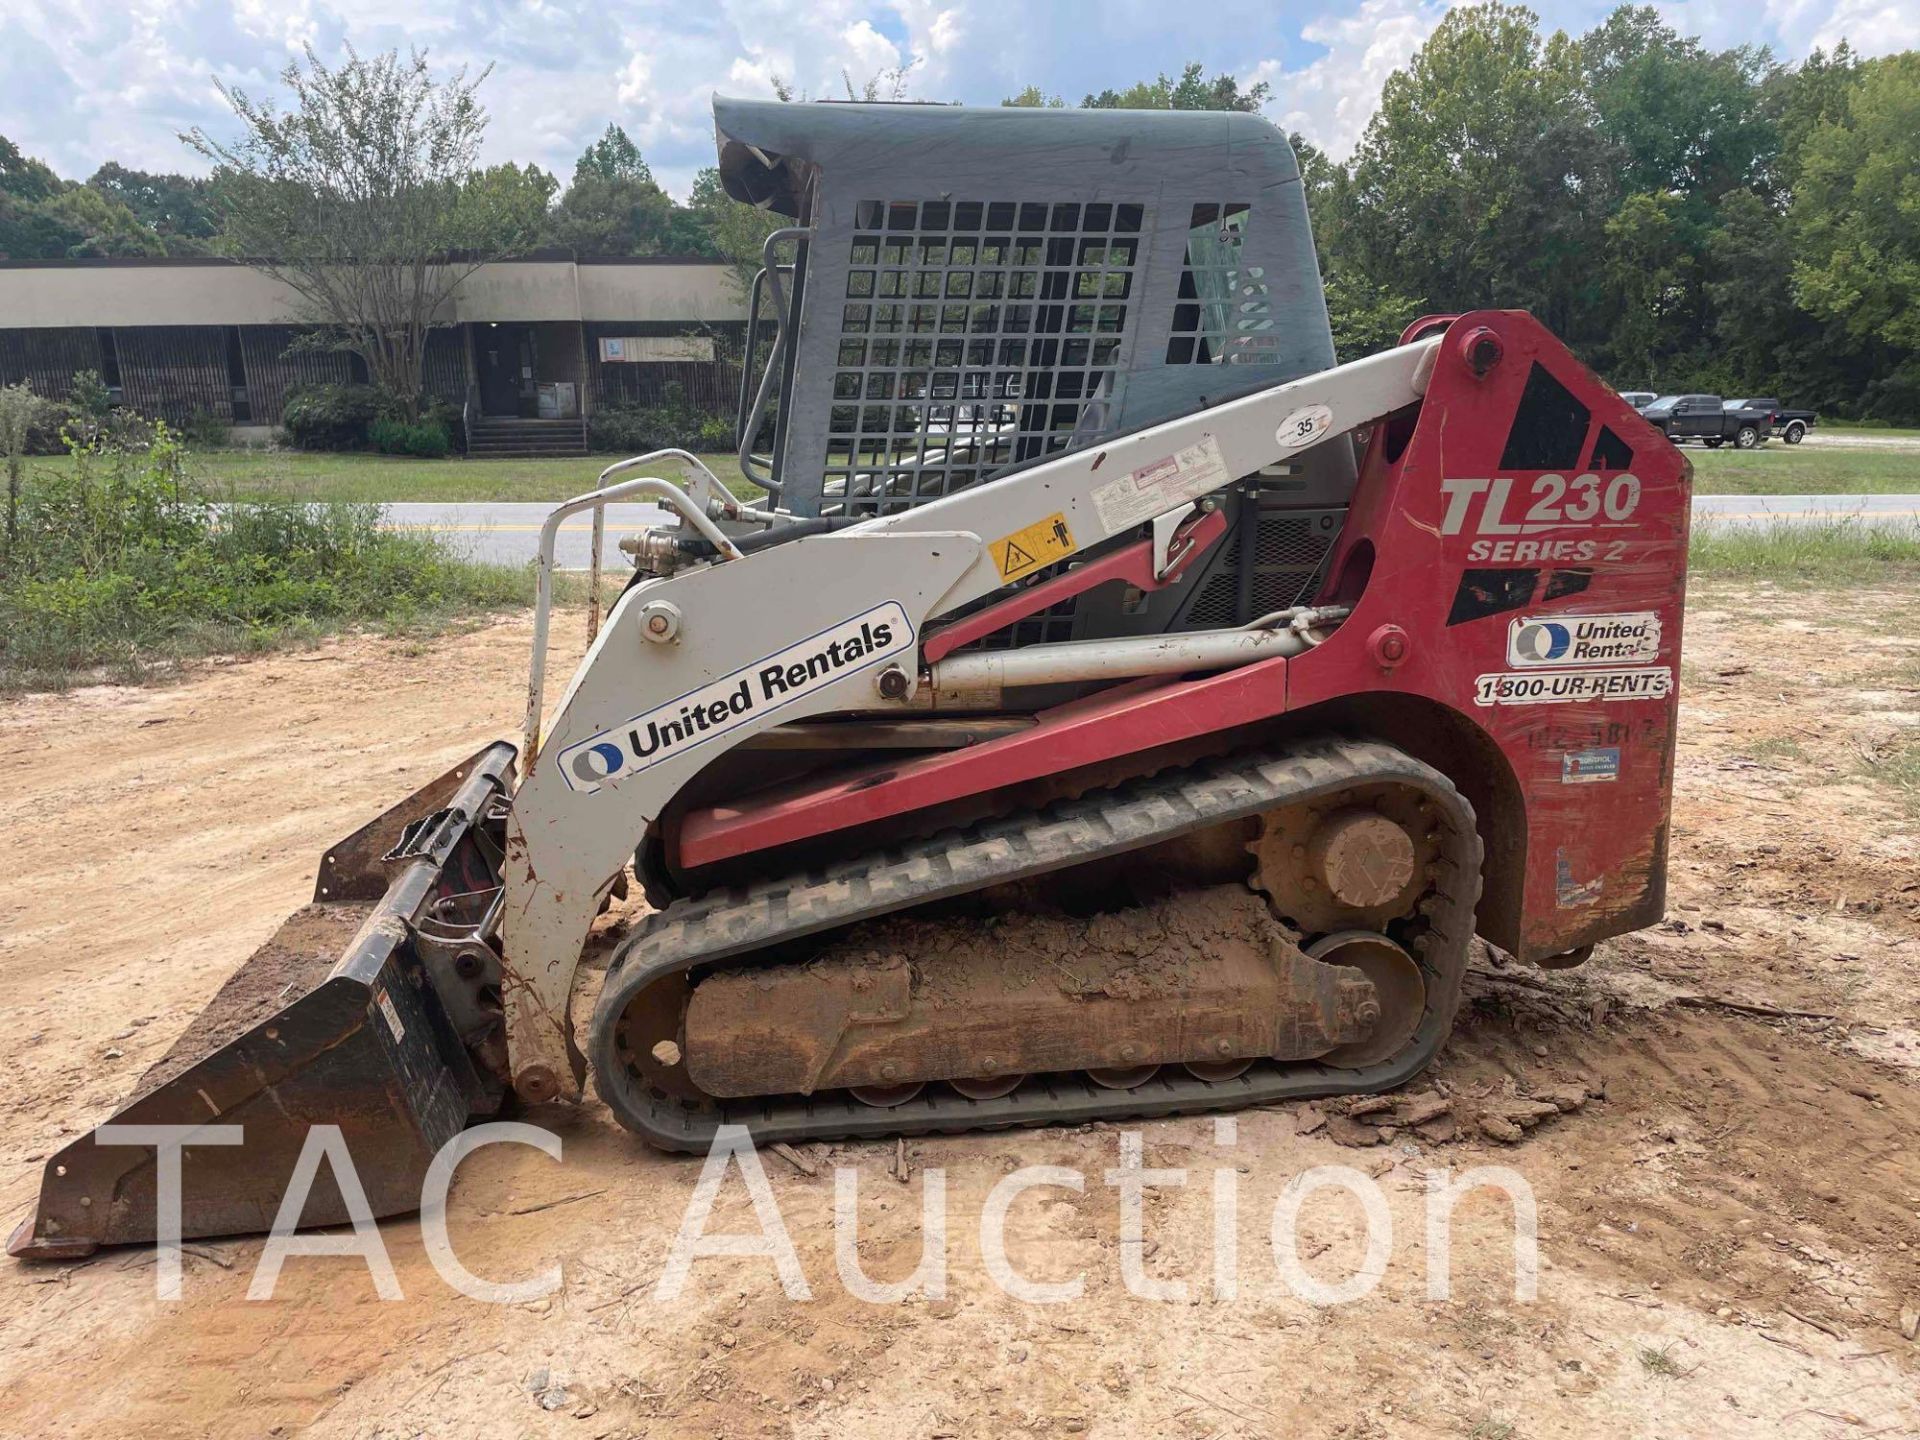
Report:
0,253,747,453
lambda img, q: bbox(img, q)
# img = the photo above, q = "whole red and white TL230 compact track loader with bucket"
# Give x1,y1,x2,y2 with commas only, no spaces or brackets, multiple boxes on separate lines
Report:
10,100,1690,1258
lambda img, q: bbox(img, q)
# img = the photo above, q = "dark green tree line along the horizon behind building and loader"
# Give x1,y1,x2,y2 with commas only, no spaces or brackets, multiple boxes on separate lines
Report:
0,4,1920,422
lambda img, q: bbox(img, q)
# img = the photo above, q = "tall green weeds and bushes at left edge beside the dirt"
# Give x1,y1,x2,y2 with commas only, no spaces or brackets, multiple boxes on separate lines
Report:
0,424,528,689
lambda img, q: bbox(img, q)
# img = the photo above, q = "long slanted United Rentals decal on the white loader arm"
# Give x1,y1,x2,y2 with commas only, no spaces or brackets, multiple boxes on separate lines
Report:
561,601,914,795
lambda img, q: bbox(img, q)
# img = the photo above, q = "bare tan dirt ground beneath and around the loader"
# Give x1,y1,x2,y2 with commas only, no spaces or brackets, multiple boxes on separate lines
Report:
0,586,1920,1440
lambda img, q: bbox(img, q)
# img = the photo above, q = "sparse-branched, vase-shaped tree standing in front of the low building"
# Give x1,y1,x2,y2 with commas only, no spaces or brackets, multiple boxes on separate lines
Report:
182,46,551,420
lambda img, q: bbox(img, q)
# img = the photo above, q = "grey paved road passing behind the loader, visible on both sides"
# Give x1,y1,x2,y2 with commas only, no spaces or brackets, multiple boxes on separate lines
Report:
386,493,1920,574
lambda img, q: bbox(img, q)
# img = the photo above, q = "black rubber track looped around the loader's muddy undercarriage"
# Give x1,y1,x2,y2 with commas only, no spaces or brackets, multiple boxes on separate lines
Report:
589,739,1480,1152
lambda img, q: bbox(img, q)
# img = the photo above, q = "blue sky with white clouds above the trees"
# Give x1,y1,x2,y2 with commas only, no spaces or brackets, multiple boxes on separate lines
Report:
0,0,1920,198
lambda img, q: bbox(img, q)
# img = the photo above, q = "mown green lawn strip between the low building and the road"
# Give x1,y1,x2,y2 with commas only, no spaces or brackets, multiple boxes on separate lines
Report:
29,449,766,503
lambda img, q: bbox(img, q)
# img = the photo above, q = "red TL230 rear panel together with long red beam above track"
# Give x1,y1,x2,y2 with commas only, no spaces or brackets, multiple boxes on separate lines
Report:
676,311,1690,971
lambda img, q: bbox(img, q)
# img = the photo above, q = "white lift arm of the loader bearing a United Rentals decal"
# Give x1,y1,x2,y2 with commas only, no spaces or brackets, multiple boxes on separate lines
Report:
501,338,1442,1102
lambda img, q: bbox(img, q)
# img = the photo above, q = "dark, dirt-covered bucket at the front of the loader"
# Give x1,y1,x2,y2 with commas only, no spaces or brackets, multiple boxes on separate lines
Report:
8,743,515,1260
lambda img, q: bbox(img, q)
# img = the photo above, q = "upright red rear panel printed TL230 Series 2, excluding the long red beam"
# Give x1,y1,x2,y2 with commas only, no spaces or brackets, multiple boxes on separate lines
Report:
1288,311,1692,956
